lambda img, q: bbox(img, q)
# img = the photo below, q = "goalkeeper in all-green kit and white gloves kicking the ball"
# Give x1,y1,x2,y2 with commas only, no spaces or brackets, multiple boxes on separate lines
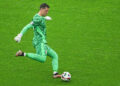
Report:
14,3,61,78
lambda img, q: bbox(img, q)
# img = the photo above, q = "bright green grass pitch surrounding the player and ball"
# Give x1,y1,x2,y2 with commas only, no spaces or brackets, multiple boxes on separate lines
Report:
0,0,120,86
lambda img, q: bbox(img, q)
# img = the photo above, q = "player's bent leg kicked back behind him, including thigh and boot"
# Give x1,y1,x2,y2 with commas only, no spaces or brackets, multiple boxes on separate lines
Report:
16,43,46,62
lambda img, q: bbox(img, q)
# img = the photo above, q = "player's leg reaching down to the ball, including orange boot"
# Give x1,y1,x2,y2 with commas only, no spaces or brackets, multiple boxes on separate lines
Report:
47,46,61,78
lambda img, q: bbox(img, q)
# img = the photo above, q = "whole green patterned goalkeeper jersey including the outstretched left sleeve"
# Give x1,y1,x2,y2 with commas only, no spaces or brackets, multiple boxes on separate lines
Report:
20,14,46,45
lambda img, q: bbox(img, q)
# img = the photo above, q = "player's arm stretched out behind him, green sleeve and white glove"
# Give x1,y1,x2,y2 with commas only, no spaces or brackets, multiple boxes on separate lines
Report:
14,22,33,43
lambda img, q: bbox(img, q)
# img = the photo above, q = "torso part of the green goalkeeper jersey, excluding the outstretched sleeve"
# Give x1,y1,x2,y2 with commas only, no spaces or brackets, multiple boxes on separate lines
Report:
33,14,46,43
